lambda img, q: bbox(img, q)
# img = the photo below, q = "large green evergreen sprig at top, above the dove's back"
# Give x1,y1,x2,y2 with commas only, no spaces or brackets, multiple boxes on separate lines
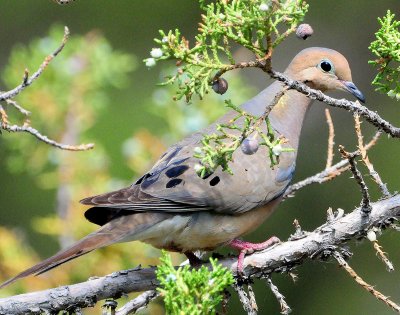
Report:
144,0,308,102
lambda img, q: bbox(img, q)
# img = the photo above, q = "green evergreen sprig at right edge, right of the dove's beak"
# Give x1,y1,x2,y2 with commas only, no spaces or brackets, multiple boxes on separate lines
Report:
369,10,400,100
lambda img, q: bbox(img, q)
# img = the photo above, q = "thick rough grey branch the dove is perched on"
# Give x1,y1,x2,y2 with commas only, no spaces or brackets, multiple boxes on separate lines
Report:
0,195,400,314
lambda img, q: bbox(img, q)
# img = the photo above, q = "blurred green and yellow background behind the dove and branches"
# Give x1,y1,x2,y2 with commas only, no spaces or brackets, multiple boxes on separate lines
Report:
0,0,400,315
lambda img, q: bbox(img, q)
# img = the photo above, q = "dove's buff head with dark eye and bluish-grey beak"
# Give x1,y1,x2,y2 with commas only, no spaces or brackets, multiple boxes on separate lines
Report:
285,47,365,103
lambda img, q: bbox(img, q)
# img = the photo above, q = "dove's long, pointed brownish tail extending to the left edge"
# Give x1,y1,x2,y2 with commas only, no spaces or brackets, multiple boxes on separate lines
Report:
0,229,121,289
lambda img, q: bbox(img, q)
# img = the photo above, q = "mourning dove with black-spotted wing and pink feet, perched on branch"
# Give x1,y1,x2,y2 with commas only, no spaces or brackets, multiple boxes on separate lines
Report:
2,47,364,286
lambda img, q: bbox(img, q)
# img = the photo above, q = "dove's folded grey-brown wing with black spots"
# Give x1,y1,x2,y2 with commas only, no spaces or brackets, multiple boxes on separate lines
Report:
82,100,295,214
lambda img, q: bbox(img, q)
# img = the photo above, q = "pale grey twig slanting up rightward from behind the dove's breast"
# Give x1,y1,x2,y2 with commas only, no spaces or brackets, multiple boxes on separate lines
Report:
283,131,382,198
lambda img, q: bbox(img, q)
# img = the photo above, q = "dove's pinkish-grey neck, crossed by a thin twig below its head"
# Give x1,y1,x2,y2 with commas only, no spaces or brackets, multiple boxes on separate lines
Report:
243,81,312,149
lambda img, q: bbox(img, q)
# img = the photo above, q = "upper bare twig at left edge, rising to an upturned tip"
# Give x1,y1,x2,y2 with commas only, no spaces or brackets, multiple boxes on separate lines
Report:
0,26,69,102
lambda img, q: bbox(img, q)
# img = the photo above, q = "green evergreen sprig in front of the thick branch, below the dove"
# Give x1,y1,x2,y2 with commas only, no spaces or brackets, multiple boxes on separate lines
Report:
156,251,234,315
